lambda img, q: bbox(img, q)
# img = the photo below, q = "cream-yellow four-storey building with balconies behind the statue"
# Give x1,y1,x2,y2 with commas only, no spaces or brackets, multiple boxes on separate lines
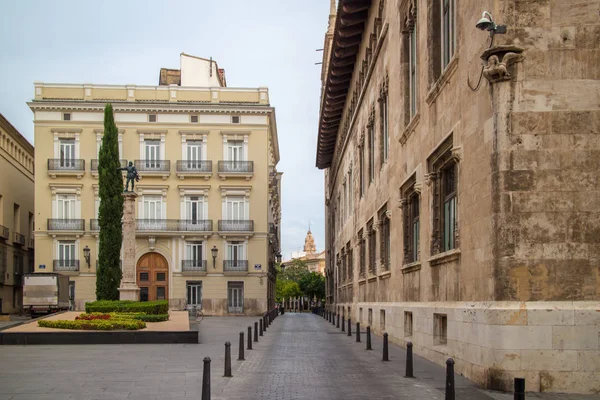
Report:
28,53,281,315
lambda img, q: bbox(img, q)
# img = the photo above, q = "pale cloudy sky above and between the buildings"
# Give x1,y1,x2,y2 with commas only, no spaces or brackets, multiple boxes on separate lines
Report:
0,0,329,259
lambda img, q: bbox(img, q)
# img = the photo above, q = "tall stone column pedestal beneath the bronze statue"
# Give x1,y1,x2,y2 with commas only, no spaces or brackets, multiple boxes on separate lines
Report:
119,192,140,301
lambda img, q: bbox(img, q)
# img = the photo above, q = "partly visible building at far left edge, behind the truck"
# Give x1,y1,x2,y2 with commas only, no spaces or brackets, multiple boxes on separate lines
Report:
0,114,34,314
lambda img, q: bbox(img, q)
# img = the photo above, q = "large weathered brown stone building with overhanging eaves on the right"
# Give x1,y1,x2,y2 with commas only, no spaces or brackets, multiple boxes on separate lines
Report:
316,0,600,393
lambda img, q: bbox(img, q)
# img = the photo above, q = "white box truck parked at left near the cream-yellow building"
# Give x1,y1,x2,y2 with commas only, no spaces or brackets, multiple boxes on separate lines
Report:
23,272,69,318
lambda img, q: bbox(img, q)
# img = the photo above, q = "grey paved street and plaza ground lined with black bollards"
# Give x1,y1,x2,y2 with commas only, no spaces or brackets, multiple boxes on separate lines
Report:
0,313,600,400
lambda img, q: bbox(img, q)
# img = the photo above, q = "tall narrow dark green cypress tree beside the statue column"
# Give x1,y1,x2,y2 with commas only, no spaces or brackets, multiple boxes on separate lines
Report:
96,104,123,300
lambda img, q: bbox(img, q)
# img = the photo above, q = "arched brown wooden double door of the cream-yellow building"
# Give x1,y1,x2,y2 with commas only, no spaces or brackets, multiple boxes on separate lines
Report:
136,253,169,301
